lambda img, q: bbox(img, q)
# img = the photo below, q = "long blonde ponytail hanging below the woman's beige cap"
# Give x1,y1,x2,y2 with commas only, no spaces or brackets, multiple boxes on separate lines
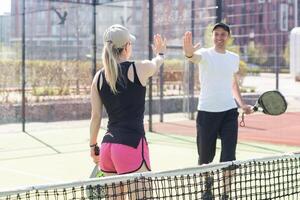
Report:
102,42,123,94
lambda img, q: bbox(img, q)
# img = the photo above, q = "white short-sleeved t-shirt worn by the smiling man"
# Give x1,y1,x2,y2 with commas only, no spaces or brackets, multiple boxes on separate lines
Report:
194,48,239,112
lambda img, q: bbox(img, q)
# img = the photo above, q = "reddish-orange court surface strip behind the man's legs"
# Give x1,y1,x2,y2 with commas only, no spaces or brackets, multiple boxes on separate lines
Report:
153,112,300,147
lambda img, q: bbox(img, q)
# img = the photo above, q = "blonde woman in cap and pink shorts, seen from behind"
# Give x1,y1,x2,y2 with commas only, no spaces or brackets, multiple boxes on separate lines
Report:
90,25,166,196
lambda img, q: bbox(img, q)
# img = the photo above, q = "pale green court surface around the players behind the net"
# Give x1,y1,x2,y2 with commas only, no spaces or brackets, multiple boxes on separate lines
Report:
0,117,299,190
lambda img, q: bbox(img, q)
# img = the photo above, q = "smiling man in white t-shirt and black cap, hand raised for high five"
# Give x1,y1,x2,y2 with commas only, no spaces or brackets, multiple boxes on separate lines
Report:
183,23,252,199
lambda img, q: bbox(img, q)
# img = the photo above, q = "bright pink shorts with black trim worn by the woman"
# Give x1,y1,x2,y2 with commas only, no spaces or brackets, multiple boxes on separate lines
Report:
99,138,151,174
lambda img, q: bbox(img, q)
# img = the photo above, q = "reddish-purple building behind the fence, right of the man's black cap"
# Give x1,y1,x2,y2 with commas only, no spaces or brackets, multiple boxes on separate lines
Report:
222,0,299,67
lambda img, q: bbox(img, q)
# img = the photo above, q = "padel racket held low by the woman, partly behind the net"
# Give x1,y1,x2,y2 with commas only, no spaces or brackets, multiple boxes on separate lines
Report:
86,146,105,199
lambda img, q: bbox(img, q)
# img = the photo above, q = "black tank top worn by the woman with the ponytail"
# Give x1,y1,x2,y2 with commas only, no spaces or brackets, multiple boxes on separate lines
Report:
97,62,146,148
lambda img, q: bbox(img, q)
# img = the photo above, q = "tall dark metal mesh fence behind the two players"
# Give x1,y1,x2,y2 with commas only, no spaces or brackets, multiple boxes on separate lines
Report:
0,0,299,130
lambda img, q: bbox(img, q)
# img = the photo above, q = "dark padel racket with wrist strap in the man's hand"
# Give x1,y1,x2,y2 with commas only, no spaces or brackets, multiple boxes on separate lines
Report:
240,90,287,127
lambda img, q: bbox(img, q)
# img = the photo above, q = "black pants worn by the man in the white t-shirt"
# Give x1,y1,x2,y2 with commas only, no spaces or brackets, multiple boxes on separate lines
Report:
197,108,239,165
